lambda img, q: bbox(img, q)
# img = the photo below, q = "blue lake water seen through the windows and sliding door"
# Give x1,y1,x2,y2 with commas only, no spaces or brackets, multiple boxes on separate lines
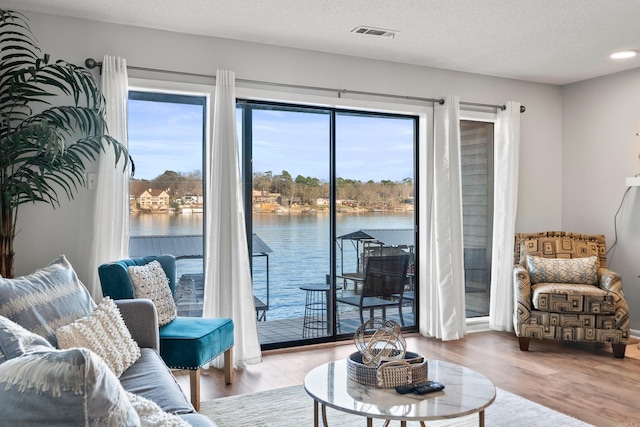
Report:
131,213,413,320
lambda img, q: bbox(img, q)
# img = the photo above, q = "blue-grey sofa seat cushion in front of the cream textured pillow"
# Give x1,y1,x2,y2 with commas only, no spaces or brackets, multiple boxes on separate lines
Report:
120,348,194,414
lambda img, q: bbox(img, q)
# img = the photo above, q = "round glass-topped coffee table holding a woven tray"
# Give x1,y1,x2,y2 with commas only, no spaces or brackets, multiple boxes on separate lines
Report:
304,359,496,427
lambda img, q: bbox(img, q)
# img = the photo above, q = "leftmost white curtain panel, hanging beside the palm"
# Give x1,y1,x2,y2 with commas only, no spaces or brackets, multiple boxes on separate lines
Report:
88,55,129,302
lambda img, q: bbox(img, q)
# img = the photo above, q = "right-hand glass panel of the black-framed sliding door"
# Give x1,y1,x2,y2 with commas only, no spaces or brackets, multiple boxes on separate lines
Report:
335,112,417,334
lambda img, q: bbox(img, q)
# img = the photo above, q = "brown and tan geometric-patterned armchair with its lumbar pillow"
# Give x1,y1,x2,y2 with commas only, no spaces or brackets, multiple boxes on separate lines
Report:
513,231,629,358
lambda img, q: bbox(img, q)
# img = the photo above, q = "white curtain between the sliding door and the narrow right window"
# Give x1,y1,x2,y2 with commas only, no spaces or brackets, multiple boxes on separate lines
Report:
420,96,466,340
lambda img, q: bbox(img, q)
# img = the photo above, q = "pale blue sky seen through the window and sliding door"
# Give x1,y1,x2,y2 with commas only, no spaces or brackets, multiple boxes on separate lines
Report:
129,100,413,182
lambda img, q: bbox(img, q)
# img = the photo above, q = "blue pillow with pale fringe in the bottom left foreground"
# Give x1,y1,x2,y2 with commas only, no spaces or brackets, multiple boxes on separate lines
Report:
0,348,140,427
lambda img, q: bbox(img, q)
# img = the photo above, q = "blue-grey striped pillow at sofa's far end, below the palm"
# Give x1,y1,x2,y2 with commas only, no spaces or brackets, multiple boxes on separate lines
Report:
0,255,96,347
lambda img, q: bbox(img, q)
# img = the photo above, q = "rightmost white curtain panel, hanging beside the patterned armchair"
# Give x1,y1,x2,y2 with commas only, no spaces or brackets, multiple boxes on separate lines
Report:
489,102,520,331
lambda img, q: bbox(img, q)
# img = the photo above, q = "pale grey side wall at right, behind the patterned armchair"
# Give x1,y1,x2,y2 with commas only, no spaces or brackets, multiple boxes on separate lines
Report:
562,69,640,329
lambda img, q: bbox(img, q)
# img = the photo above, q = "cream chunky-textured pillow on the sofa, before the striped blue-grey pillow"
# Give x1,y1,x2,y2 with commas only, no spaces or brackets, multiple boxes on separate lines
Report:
56,297,140,378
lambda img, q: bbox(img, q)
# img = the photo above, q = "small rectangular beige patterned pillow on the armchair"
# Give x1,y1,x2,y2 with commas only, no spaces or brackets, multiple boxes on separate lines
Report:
527,255,598,285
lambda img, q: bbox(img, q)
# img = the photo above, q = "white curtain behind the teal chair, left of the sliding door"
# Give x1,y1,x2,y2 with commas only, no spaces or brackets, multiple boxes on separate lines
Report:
203,70,262,368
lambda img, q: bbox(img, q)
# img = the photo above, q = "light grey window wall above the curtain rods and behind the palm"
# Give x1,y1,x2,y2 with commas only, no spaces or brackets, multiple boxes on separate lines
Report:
16,13,562,302
